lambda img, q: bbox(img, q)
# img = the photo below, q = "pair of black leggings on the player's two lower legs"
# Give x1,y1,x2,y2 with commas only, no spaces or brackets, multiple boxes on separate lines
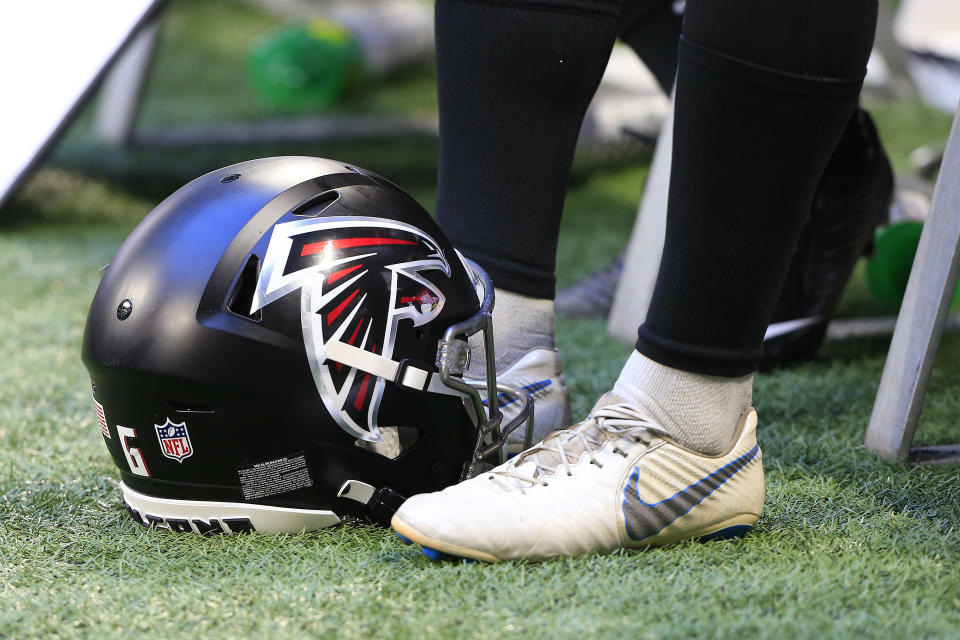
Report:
436,0,876,376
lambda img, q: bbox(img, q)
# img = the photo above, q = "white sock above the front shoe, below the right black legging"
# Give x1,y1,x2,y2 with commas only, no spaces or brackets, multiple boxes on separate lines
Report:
613,351,753,455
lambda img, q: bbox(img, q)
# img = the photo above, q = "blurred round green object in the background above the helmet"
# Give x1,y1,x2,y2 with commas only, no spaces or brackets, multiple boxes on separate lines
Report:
250,20,363,110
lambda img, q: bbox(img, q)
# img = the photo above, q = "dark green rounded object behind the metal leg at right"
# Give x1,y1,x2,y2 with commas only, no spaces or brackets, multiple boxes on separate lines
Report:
867,220,960,309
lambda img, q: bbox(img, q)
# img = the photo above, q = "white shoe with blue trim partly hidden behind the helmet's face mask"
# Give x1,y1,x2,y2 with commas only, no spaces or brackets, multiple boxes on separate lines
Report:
464,347,573,453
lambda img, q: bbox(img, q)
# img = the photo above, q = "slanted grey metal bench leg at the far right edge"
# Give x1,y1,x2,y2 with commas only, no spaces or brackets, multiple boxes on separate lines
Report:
866,102,960,462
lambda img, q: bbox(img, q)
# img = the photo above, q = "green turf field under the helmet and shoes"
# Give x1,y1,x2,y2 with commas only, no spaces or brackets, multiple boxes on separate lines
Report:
0,2,960,639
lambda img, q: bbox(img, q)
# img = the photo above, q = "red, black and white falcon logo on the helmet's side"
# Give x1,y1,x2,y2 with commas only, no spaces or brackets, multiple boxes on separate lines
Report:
251,216,450,442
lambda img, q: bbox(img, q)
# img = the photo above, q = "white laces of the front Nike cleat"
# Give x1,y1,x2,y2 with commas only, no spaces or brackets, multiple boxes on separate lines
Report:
487,402,668,493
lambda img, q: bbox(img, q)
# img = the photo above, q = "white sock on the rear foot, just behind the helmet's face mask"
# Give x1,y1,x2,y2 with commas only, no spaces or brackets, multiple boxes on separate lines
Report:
467,287,556,378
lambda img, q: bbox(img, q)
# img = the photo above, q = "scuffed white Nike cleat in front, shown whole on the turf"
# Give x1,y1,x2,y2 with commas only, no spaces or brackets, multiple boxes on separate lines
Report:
392,394,764,562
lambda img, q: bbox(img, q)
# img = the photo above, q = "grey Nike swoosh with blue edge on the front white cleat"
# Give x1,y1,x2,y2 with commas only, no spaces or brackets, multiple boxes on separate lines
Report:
623,445,760,541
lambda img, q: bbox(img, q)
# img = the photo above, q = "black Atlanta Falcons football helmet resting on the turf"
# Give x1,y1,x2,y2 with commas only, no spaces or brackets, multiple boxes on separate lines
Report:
83,157,532,533
